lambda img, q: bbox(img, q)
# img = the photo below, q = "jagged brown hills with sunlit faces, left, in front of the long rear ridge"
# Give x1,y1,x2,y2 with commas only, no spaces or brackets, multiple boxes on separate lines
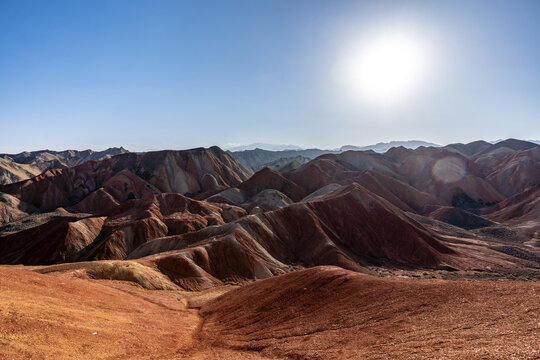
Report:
0,194,245,265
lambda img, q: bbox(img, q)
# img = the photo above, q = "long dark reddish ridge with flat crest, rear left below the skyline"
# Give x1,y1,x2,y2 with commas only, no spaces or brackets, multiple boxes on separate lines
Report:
0,147,251,211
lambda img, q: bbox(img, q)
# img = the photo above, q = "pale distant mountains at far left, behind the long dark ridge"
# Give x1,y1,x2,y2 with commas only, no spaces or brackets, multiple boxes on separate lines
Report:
0,147,129,184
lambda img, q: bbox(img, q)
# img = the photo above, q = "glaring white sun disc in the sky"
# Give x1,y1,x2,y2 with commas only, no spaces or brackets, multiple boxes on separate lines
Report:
343,31,429,105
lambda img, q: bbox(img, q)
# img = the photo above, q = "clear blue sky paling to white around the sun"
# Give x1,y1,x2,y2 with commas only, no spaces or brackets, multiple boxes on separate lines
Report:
0,0,540,153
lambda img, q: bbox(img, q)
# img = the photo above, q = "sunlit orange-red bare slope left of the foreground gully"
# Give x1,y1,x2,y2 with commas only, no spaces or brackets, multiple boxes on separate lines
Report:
0,267,264,359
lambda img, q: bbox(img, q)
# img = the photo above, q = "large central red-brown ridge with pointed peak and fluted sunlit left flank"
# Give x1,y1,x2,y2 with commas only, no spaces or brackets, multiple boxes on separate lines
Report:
128,184,456,289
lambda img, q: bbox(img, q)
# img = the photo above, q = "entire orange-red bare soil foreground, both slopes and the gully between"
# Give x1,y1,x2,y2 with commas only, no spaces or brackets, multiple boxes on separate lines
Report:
0,266,540,359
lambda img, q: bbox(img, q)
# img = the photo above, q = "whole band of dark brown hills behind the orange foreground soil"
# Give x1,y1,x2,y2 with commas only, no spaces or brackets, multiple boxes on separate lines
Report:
0,141,540,289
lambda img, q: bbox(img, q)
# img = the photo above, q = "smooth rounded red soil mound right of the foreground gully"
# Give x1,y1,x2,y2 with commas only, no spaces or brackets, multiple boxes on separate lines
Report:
201,267,540,359
